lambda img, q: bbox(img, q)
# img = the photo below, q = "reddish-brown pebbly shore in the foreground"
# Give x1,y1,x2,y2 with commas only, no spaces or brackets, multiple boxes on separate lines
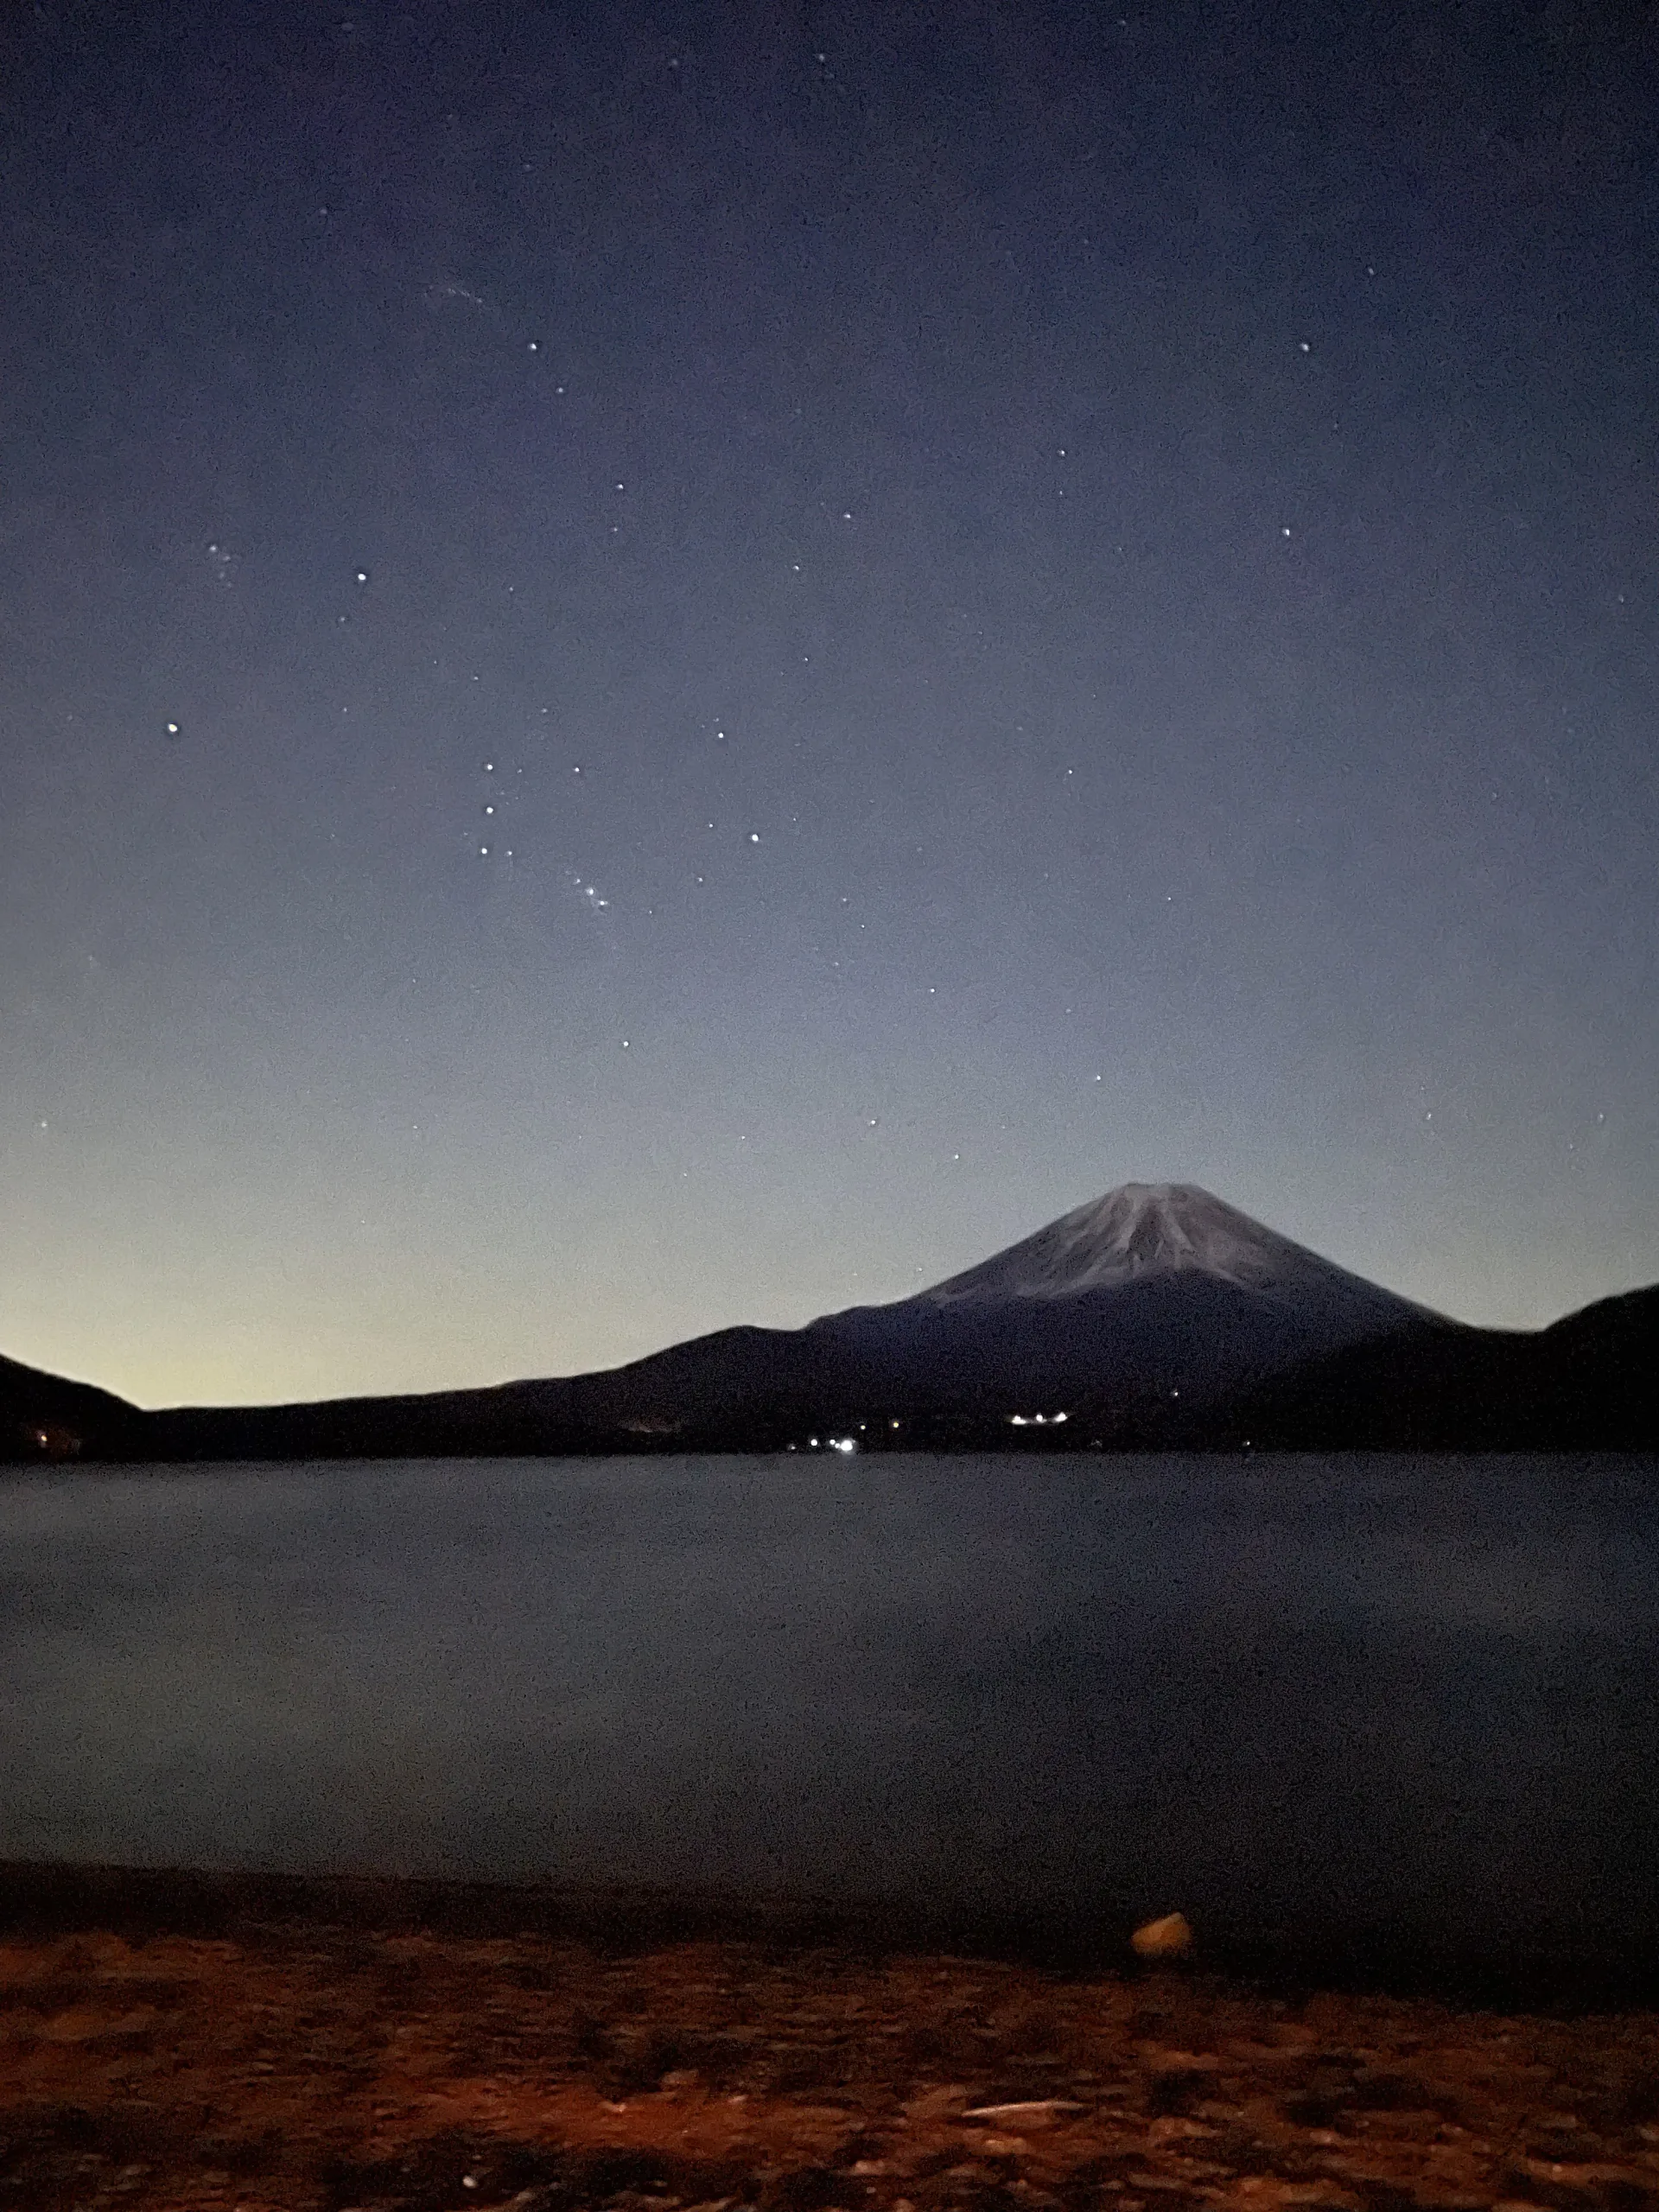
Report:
0,1865,1659,2212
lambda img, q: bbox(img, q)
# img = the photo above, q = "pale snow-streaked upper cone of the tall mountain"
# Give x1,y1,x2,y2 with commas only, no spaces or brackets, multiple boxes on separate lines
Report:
907,1184,1407,1305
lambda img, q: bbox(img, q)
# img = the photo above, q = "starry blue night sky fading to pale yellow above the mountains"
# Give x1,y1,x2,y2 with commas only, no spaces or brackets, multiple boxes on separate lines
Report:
0,0,1659,1405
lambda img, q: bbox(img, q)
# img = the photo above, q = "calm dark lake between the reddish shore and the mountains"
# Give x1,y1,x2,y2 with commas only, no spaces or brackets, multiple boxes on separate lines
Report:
0,1455,1659,1958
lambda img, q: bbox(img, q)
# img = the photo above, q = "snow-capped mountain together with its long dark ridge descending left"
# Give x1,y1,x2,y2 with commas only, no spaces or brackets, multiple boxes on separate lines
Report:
137,1184,1455,1455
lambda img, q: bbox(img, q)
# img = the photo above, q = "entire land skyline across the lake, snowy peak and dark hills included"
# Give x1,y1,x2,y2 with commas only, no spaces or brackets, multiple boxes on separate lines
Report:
0,1184,1659,1460
